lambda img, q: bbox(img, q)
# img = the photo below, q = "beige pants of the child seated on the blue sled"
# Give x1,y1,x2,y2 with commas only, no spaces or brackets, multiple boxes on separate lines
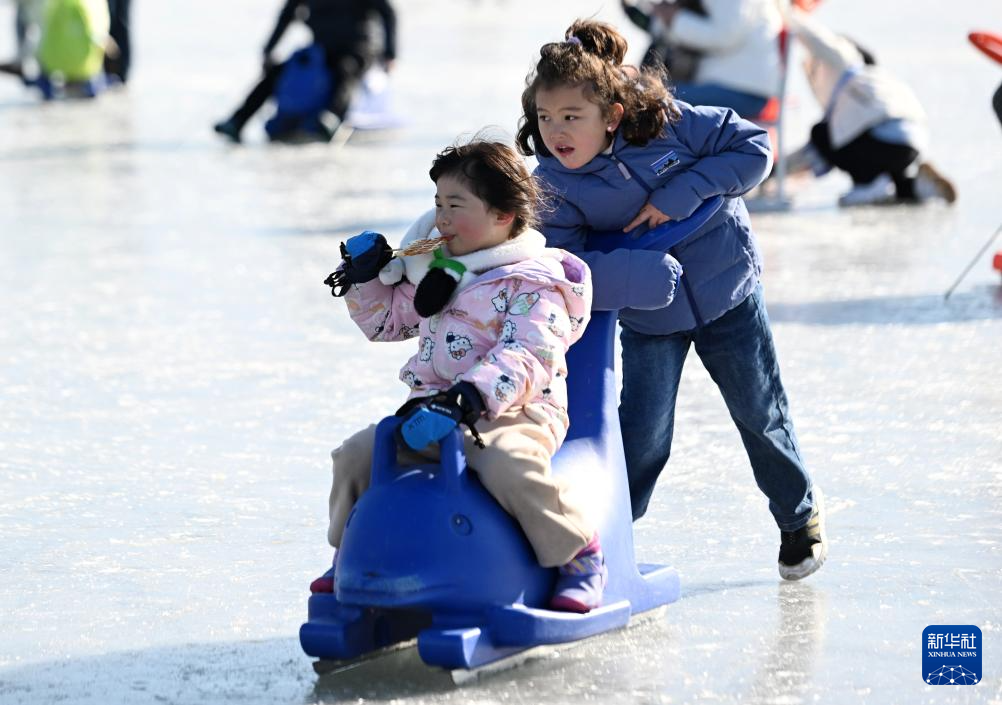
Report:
327,410,594,568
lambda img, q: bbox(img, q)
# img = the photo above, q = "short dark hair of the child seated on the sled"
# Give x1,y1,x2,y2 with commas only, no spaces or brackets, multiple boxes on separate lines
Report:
428,136,541,239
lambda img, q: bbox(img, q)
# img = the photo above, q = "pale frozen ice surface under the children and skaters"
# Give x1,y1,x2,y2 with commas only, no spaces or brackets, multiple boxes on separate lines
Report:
0,0,1002,705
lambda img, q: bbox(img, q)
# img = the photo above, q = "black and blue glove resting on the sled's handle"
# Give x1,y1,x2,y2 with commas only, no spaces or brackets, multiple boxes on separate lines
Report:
397,382,484,451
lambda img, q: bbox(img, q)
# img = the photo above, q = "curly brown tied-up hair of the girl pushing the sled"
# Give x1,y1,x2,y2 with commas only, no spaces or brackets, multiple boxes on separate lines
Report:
515,20,681,156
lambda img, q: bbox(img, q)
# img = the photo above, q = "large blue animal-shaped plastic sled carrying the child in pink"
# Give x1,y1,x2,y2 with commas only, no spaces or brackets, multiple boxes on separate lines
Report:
300,197,722,669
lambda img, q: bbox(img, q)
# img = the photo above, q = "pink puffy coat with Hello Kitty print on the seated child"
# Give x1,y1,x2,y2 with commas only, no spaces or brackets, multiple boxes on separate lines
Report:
345,211,591,445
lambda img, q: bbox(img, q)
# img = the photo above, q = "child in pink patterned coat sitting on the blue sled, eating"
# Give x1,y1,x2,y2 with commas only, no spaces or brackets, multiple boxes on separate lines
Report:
311,139,606,613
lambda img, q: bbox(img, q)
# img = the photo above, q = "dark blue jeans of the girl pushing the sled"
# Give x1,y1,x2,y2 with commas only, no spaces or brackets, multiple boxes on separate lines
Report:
619,284,813,531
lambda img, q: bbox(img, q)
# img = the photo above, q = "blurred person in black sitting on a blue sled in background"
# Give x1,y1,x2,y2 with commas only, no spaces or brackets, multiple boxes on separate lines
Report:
213,0,397,142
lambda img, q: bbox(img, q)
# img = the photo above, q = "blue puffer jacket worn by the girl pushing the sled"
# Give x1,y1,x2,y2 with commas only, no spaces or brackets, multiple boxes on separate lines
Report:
534,101,773,335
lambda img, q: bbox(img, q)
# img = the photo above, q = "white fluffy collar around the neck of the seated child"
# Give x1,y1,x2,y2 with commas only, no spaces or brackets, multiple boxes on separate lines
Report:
380,210,546,290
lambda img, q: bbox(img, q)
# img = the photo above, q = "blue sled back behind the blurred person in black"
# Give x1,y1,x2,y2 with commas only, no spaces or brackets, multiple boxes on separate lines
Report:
265,44,334,140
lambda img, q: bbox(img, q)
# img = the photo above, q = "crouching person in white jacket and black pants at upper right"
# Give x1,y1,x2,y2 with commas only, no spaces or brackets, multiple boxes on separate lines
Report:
787,8,957,206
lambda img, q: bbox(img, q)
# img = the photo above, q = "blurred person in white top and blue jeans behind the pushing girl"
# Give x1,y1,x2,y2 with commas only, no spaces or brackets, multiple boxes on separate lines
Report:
622,0,783,119
